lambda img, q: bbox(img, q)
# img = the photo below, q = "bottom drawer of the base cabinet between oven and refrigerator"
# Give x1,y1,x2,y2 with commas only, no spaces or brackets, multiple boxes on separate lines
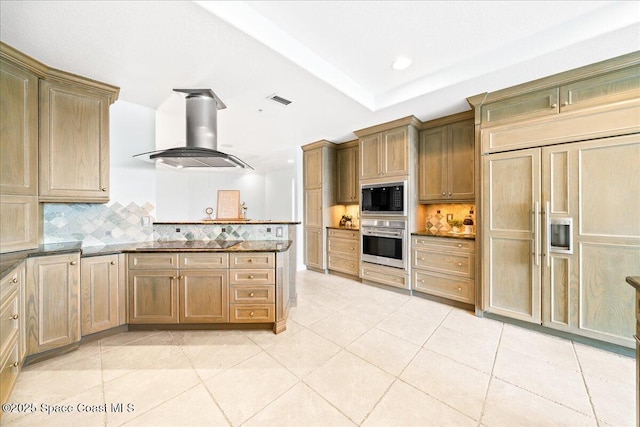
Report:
413,270,475,304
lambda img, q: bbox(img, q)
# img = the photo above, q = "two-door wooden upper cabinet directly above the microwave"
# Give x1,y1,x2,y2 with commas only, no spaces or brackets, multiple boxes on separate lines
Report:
355,116,420,180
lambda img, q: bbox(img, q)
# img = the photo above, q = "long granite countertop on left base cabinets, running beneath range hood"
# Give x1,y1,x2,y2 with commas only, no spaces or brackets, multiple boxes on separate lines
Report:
0,240,291,278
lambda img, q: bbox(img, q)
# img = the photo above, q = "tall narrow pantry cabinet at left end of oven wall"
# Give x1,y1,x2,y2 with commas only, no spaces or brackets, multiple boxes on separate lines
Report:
302,140,336,272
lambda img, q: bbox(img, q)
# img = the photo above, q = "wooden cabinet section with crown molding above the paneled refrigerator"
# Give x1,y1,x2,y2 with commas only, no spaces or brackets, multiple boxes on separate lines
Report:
468,52,640,153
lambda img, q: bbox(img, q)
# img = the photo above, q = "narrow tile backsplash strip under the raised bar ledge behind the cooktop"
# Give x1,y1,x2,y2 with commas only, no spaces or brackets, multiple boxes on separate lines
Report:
153,224,289,242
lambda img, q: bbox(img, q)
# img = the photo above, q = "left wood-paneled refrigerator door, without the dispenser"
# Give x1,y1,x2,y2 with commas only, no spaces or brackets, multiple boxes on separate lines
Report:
482,149,541,323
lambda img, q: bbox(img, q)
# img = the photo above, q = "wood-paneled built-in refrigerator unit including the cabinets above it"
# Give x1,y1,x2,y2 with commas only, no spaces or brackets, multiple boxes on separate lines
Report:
469,53,640,347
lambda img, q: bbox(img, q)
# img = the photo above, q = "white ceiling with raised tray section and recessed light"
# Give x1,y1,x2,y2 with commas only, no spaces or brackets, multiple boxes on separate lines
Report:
0,0,640,171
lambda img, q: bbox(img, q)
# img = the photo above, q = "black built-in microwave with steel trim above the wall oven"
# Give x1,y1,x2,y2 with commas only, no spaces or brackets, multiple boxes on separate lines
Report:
360,181,407,216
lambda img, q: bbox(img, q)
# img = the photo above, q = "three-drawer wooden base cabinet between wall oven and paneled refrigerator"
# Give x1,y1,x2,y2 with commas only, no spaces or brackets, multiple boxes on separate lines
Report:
411,236,475,304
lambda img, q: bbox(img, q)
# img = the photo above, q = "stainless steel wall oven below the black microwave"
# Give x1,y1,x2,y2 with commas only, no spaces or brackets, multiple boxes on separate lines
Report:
360,219,407,268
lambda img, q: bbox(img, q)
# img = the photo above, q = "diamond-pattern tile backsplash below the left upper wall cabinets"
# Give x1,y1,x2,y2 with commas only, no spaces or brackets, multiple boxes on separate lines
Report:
44,202,155,246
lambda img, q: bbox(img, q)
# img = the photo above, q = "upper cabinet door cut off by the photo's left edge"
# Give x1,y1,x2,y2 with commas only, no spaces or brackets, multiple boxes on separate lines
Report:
0,58,38,196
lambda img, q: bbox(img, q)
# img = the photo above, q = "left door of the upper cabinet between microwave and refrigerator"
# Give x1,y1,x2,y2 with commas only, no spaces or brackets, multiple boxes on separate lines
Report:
418,126,447,202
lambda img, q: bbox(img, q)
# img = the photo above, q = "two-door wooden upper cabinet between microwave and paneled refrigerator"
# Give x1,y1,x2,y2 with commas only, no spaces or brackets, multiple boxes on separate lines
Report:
418,114,476,203
